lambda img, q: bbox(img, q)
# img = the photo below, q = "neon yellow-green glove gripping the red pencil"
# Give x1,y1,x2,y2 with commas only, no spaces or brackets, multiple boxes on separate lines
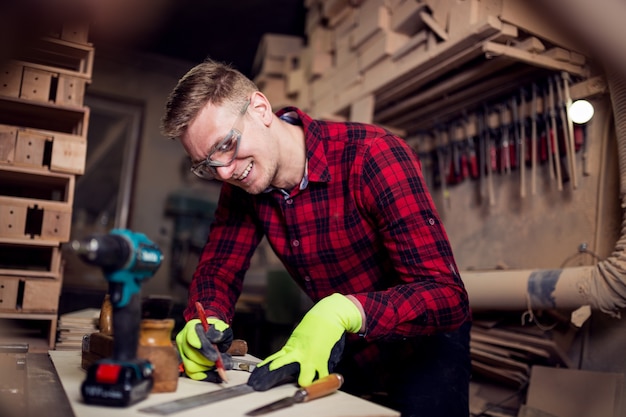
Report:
176,318,233,382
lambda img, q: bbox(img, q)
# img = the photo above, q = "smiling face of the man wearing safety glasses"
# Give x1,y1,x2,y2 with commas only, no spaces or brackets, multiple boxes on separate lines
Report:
180,94,278,194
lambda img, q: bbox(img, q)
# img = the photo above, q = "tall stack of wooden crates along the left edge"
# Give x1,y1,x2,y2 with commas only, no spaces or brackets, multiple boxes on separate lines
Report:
0,24,94,349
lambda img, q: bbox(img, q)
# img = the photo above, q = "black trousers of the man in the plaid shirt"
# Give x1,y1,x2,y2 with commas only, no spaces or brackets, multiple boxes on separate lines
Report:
336,322,471,417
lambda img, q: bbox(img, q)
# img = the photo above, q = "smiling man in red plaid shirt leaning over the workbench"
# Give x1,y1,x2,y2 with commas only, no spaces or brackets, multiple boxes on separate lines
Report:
162,60,470,417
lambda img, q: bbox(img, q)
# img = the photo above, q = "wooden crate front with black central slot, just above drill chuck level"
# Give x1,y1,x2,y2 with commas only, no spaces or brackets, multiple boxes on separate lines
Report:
0,197,72,243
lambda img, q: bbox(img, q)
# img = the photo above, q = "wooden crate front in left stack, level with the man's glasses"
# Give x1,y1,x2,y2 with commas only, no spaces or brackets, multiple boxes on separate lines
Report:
0,125,87,174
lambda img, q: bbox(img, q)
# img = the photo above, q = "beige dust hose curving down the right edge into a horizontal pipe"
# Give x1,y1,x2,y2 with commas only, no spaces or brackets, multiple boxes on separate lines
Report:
462,0,626,317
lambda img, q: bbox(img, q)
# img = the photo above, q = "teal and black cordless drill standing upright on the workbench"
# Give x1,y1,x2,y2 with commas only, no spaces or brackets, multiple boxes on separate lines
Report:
71,229,163,407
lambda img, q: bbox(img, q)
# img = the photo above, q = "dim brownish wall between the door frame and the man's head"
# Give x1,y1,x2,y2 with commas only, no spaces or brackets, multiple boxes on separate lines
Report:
87,49,192,298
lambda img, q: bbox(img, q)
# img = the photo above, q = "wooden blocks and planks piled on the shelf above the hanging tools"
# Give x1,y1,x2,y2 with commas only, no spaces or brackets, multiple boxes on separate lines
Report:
251,0,590,129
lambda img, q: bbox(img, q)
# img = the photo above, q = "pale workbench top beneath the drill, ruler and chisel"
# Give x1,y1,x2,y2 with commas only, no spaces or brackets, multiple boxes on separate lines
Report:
39,351,400,417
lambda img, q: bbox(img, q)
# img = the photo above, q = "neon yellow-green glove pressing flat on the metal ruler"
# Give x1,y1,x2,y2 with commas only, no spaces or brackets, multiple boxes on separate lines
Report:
248,294,362,391
